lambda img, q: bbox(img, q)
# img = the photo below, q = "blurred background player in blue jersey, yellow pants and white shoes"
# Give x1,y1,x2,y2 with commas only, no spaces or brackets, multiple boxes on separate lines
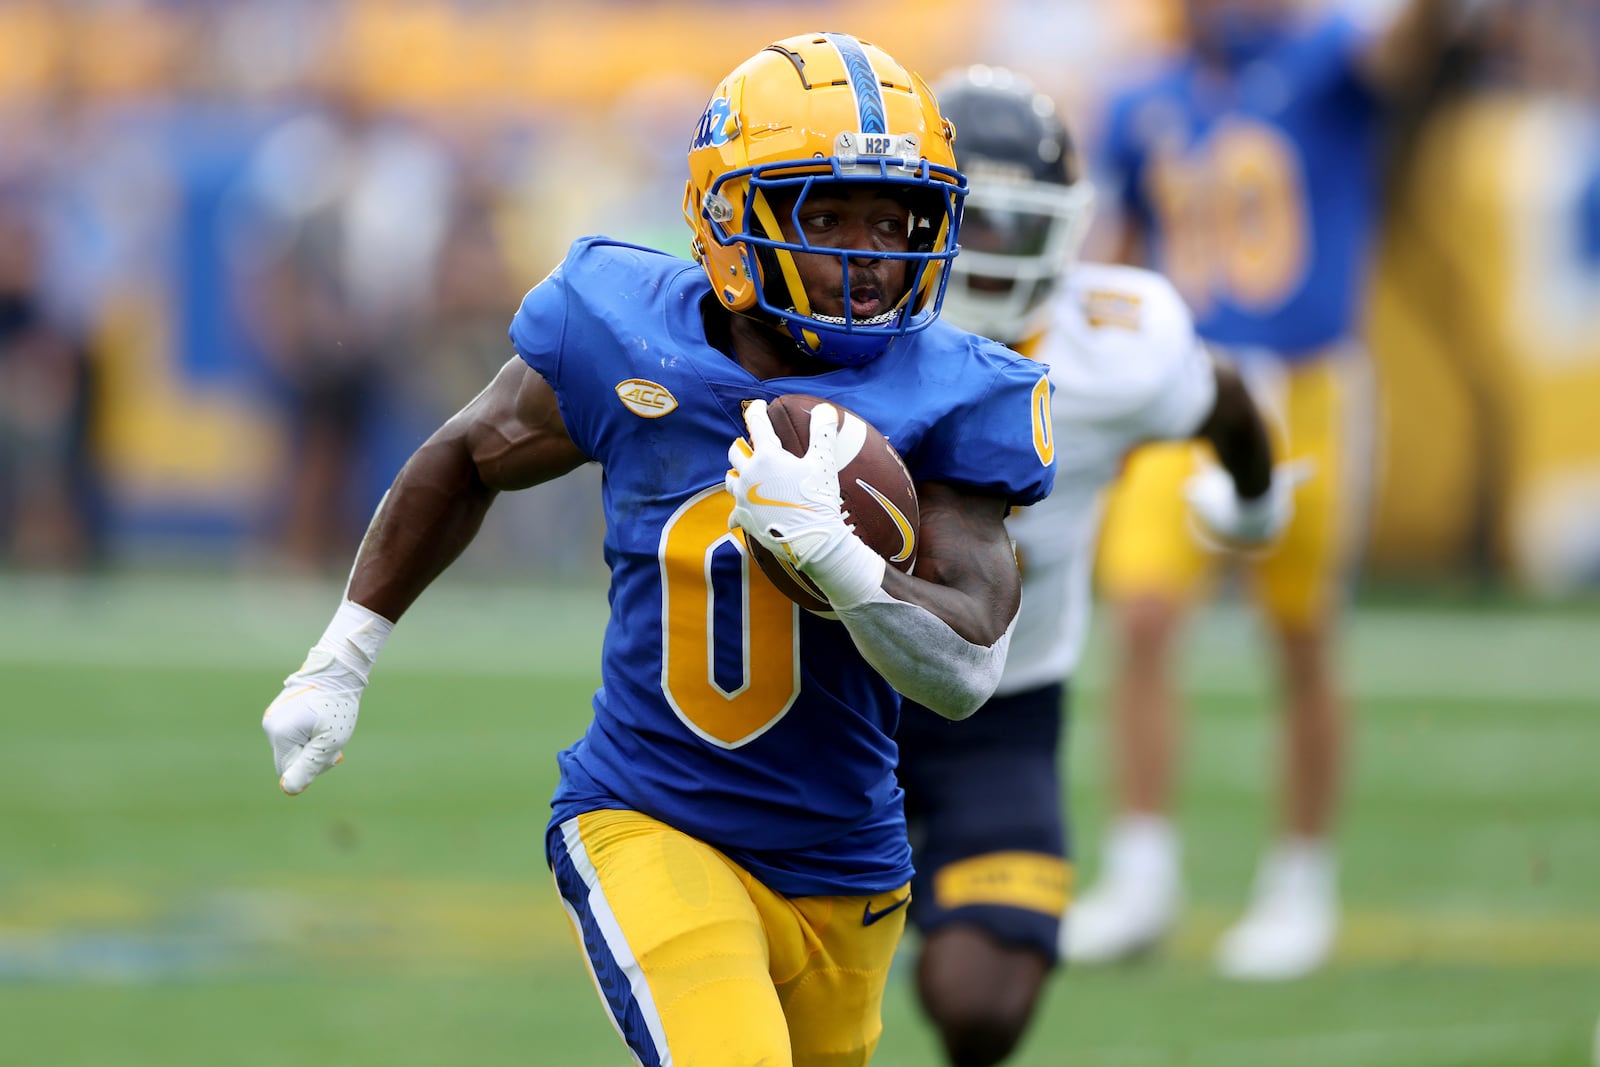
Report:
1064,0,1477,979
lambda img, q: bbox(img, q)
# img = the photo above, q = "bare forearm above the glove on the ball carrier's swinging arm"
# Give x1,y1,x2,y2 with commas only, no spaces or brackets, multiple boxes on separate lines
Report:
346,426,496,622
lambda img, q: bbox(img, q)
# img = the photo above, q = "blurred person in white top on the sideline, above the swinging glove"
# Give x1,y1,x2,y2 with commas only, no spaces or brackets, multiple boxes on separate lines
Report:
237,78,456,571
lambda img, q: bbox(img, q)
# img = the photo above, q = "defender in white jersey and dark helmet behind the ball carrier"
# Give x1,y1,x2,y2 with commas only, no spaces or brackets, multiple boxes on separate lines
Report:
898,67,1293,1067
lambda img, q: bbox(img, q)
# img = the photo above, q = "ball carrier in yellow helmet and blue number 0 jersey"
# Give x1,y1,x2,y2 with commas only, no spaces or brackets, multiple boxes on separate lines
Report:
264,34,1054,1067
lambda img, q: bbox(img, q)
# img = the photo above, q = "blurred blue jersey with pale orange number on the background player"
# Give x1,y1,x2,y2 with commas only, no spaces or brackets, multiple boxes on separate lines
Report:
1106,16,1381,358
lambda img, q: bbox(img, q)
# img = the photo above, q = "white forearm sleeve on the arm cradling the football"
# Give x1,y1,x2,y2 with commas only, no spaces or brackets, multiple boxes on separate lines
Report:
837,589,1016,718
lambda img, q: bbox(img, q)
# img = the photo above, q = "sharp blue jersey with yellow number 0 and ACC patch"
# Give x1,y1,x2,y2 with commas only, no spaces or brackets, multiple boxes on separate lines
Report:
510,238,1054,896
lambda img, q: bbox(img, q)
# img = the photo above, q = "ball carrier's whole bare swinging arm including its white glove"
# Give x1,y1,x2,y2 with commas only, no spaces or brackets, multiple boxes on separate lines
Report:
261,358,584,795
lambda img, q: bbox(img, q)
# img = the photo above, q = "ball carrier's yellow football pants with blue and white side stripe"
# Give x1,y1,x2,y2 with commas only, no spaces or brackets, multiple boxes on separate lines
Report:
550,811,909,1067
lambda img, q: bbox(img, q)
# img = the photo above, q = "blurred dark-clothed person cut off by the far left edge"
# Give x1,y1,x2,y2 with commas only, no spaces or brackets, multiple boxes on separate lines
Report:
0,189,102,569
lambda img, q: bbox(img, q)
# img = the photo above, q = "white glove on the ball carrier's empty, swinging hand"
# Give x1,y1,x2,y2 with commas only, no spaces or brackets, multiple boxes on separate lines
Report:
261,601,394,797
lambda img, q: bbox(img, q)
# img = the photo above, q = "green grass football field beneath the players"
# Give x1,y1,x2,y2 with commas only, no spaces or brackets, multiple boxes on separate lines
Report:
0,577,1600,1067
